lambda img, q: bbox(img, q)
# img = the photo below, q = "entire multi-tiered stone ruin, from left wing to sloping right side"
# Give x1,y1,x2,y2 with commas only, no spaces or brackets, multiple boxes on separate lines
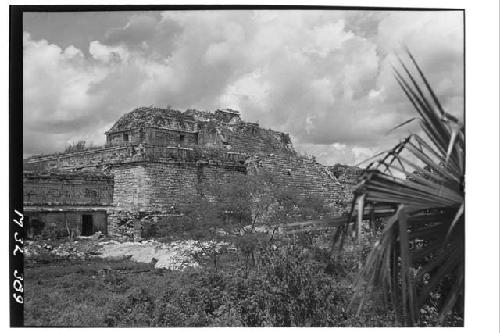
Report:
23,107,360,236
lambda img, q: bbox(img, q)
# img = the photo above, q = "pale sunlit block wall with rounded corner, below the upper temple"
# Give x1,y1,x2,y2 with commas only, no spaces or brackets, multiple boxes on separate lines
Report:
108,162,246,236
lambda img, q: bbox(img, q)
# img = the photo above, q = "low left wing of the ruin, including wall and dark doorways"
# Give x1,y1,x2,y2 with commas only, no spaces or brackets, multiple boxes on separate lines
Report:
23,171,113,238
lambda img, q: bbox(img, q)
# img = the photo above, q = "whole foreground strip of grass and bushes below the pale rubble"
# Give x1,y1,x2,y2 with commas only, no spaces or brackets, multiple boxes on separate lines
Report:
25,235,458,327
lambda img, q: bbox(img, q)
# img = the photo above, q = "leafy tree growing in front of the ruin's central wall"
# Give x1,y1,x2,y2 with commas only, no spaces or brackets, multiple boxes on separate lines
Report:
186,173,327,265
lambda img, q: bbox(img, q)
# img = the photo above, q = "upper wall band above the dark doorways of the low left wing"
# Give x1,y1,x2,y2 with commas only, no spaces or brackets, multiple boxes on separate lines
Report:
23,172,113,206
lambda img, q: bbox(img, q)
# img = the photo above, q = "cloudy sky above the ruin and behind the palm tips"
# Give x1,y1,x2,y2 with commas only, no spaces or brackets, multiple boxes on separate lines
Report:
23,10,463,164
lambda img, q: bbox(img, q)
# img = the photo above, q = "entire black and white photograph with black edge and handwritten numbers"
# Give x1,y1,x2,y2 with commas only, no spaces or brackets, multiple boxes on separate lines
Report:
4,4,498,328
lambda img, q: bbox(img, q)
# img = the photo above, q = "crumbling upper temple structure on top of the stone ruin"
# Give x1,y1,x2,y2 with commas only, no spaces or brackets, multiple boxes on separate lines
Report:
105,107,293,153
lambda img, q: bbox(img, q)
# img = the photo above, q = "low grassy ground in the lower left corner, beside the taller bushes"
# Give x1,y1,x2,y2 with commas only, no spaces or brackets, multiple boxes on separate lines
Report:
25,259,158,326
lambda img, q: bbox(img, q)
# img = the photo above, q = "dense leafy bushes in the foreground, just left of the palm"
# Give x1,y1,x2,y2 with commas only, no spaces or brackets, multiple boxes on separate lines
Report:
100,241,382,327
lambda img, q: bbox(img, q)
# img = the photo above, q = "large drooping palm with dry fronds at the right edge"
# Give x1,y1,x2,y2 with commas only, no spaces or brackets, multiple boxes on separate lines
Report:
335,50,465,326
